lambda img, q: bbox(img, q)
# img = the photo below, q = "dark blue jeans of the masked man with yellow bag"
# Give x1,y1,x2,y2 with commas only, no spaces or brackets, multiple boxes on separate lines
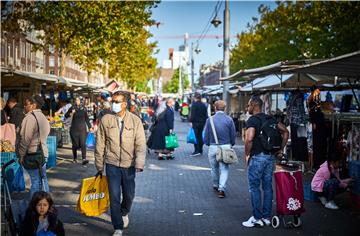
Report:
106,164,135,230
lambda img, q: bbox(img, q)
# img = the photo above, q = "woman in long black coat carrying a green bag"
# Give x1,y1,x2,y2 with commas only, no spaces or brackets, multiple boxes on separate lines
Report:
148,98,174,160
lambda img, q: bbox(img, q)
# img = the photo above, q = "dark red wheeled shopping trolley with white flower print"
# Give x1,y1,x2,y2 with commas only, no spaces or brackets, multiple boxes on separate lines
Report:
271,159,305,228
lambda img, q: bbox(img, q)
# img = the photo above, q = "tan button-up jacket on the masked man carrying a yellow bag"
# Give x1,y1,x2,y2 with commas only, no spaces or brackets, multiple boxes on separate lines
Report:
95,111,146,171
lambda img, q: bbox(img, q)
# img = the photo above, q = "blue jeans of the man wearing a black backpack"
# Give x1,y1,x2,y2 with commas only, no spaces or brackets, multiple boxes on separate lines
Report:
248,153,274,220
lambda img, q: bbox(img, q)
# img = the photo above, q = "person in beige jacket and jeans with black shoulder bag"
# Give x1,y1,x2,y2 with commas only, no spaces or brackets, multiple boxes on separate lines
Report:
17,95,50,198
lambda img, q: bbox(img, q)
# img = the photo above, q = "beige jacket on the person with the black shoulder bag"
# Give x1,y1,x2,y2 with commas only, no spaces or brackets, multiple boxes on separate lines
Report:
18,109,50,157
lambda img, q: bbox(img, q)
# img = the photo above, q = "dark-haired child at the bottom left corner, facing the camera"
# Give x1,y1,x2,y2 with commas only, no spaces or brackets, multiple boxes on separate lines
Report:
20,191,65,236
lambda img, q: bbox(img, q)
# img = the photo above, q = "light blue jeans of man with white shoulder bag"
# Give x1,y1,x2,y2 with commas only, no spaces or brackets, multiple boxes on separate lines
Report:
208,145,230,192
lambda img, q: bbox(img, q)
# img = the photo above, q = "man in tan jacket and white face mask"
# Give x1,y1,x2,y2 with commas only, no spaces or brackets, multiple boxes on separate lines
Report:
95,91,146,236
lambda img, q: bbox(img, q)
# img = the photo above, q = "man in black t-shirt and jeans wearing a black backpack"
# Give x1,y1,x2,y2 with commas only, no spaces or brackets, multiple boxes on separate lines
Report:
242,96,289,227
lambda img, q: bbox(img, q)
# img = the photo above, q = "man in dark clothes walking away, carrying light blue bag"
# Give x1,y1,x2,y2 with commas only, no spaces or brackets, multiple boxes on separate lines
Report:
189,93,207,157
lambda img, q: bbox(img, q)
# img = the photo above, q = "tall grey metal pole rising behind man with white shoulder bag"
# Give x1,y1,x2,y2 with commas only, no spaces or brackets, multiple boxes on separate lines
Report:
223,0,230,112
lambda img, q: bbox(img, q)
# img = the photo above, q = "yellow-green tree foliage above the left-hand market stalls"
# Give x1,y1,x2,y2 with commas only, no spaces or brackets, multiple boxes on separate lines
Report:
1,1,158,89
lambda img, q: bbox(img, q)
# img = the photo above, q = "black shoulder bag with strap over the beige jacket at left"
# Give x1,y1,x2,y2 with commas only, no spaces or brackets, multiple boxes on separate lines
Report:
23,112,46,170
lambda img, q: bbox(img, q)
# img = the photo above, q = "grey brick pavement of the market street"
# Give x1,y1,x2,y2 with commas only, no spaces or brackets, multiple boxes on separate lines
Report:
43,113,360,236
